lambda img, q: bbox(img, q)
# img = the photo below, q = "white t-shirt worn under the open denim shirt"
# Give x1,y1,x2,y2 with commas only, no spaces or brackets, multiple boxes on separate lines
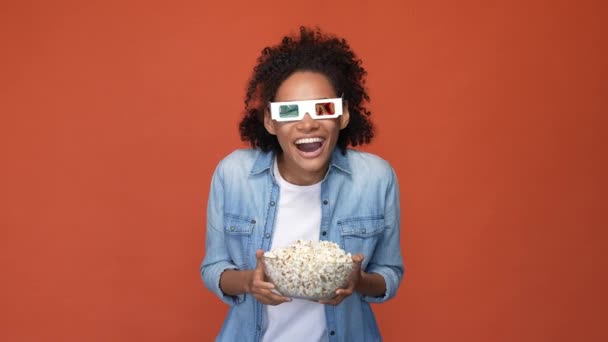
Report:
262,159,329,342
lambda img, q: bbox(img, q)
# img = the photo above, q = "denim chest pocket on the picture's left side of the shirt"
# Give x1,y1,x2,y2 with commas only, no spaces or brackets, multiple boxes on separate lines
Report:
224,214,256,269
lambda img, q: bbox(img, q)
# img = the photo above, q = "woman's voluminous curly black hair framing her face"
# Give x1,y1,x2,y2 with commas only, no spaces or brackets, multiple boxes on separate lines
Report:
239,27,374,153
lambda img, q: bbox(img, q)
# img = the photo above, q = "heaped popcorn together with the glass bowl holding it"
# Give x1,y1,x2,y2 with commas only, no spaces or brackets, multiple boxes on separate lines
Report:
263,240,354,300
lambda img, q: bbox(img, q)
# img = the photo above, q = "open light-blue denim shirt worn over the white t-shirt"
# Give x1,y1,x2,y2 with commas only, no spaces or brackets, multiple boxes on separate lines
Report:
201,149,404,342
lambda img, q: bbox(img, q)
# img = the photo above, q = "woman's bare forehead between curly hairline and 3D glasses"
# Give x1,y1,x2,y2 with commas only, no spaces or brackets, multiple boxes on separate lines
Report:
275,71,336,102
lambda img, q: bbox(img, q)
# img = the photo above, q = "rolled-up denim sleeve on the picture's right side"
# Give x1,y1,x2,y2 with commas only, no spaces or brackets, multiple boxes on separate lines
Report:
363,168,404,303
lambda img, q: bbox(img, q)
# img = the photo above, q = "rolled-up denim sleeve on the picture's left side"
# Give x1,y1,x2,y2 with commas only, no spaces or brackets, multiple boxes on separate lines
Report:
200,163,245,305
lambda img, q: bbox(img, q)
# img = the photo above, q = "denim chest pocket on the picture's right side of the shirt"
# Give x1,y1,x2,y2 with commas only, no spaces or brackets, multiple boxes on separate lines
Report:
338,215,385,263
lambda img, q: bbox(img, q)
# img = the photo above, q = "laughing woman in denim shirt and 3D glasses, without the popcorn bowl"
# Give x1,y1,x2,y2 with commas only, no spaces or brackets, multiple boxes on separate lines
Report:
201,27,404,341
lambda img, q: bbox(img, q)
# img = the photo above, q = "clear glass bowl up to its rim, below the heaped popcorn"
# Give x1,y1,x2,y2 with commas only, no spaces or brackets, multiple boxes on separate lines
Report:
262,256,354,300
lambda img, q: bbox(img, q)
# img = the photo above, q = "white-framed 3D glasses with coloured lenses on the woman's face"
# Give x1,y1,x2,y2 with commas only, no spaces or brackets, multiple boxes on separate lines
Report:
270,97,342,121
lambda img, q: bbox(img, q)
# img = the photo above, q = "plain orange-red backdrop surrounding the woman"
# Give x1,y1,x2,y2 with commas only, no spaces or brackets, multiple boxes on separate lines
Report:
0,0,608,341
